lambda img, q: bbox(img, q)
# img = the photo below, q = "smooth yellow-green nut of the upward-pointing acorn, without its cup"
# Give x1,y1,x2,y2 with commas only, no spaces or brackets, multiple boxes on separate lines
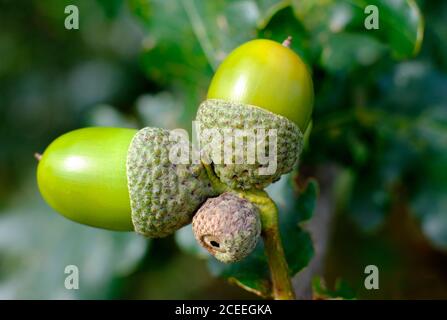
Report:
207,39,314,133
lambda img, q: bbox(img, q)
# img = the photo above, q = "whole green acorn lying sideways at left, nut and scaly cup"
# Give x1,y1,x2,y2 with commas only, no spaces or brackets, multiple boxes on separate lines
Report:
37,128,215,237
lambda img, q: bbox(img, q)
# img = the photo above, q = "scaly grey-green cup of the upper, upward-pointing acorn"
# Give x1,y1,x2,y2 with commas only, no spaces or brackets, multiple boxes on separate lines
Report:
196,100,303,189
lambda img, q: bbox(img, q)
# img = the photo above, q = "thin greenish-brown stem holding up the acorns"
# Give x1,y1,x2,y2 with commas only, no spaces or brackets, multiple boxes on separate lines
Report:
205,165,295,300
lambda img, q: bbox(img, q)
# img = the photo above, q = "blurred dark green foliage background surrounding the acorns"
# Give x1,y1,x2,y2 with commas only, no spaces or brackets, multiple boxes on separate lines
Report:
0,0,447,299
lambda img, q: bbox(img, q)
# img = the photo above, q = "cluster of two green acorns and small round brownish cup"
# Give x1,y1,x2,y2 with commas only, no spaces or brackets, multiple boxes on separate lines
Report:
37,40,313,262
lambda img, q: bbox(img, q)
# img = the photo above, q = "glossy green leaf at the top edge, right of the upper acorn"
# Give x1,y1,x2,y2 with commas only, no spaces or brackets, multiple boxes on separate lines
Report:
293,0,424,65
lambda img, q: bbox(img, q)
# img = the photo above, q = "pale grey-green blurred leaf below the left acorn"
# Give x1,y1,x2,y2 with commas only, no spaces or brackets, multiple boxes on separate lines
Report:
0,181,147,299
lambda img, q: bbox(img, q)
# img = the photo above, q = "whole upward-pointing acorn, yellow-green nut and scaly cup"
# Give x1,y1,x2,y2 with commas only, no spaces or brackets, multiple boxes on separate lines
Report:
196,39,314,189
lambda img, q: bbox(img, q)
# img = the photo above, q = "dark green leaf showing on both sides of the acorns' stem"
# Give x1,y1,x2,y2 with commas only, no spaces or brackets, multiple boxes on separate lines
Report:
209,175,318,297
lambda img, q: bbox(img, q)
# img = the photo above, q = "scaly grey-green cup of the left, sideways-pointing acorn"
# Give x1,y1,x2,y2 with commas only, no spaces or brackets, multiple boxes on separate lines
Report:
127,128,214,237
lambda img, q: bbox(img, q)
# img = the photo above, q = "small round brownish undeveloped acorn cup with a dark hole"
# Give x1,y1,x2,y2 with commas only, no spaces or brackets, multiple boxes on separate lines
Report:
192,192,261,263
